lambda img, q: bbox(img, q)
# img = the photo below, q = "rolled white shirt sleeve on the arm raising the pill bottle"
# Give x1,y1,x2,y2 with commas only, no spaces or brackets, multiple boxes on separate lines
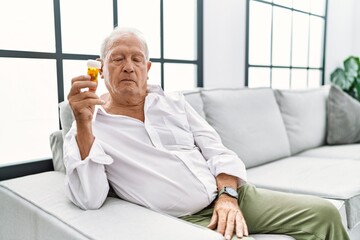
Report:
64,124,113,210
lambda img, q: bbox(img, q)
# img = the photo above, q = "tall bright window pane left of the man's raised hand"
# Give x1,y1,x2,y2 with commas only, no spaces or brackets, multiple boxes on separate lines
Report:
0,58,59,164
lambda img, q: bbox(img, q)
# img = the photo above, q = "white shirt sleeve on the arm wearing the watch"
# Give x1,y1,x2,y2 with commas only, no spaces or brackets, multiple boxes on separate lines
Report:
185,102,247,186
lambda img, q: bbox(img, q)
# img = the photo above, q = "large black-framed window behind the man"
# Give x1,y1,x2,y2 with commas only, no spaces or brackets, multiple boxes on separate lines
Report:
0,0,203,167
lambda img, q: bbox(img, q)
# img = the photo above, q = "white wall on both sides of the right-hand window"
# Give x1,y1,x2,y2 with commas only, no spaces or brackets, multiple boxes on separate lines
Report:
204,0,360,88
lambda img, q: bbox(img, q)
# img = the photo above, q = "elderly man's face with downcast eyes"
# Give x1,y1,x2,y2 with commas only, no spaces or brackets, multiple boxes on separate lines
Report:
102,34,151,98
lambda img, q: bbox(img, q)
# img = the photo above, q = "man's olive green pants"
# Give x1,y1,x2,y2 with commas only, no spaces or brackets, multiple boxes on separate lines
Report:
181,184,349,240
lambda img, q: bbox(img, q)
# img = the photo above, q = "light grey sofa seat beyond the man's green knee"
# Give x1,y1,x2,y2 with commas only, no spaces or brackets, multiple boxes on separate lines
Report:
248,156,360,230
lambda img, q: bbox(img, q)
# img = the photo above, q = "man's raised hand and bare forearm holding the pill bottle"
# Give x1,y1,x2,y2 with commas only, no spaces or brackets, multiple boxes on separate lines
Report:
68,75,104,159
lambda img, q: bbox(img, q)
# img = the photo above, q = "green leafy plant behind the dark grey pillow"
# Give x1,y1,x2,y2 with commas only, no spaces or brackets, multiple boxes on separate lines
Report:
330,56,360,101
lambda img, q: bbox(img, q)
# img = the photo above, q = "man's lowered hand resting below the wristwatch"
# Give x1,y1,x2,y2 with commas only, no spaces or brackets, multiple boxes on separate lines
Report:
208,194,249,240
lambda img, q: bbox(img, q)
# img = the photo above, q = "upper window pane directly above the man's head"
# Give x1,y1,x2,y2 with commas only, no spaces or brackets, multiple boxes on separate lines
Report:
118,0,160,58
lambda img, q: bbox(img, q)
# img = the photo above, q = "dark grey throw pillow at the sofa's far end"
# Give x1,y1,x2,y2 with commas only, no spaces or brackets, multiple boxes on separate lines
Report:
326,86,360,144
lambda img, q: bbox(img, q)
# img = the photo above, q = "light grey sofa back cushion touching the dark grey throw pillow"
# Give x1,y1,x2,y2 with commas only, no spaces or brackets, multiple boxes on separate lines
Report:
275,86,329,155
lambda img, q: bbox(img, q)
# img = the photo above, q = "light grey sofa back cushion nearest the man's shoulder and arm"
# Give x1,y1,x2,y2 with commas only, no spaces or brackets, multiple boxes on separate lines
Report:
201,88,290,168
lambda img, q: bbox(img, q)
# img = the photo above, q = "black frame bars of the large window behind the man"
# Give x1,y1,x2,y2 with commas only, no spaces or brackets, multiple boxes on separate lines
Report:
0,0,204,176
